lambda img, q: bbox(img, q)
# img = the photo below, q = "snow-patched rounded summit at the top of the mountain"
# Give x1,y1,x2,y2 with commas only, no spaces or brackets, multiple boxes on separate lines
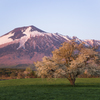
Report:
0,25,46,45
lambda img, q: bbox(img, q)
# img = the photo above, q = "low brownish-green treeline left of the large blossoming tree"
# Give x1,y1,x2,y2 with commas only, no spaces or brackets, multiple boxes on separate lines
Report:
0,67,37,79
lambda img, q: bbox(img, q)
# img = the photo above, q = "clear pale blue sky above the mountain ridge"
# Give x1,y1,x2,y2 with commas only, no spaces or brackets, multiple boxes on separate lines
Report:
0,0,100,40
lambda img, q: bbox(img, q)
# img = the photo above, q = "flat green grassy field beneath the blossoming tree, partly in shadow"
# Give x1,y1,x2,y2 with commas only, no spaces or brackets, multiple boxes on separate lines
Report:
0,78,100,100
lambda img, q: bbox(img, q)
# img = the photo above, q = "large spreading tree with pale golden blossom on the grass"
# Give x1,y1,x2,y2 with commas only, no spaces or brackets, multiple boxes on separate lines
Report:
35,41,99,85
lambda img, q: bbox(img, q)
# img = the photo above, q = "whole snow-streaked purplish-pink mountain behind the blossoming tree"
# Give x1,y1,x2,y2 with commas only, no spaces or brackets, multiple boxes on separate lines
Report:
0,26,100,65
